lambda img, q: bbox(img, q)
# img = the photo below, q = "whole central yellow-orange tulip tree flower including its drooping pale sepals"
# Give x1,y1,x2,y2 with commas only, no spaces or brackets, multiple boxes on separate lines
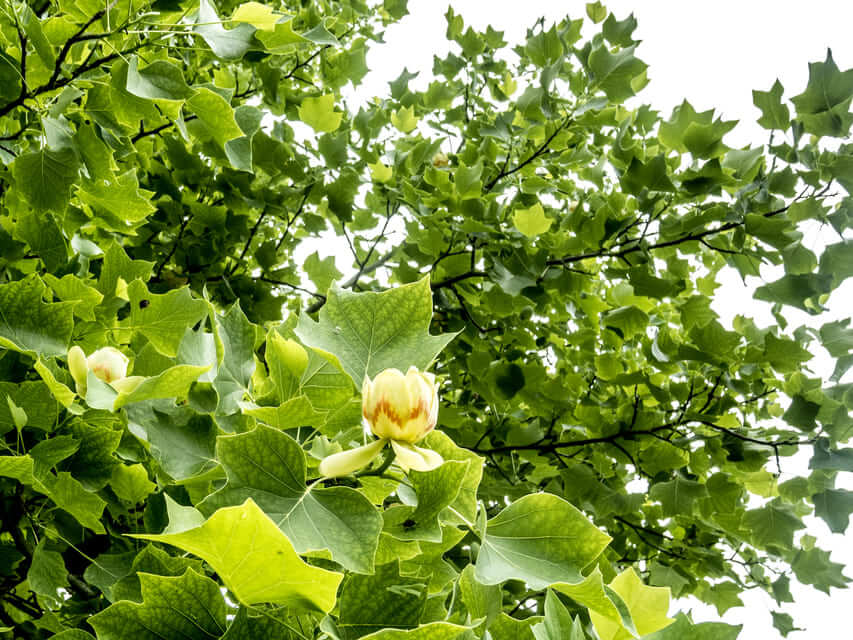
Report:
319,367,444,478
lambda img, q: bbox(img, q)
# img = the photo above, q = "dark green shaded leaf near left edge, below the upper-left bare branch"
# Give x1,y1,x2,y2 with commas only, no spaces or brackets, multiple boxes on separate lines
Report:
12,149,78,213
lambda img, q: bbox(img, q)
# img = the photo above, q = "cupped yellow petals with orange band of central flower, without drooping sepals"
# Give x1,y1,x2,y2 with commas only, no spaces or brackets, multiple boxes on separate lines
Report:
361,367,438,443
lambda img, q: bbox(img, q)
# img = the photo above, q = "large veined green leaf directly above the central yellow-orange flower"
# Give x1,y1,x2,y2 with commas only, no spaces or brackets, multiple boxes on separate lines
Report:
295,278,455,385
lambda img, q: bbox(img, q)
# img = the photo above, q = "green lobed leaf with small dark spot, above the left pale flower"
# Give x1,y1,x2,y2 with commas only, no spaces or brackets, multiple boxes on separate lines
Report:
127,280,207,356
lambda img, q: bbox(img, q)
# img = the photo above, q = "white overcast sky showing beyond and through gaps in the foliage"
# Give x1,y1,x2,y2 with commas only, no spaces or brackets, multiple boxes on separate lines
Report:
330,0,853,640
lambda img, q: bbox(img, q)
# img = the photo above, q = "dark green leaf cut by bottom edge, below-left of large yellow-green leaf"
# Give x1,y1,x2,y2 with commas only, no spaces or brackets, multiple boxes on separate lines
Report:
88,569,226,640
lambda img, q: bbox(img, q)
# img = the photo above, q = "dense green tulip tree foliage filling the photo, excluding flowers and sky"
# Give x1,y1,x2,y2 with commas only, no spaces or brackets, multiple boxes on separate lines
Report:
0,0,853,640
